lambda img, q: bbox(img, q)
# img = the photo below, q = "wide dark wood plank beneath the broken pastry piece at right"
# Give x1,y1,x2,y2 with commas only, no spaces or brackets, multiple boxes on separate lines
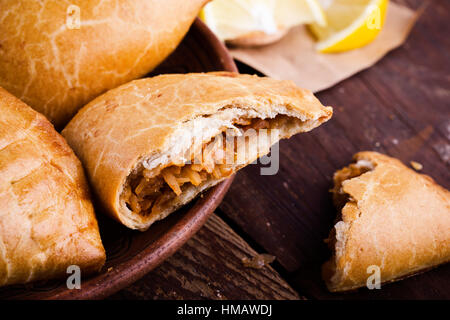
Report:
219,0,450,299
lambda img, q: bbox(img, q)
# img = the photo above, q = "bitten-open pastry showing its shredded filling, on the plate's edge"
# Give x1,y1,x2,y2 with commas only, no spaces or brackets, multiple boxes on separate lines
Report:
63,72,332,230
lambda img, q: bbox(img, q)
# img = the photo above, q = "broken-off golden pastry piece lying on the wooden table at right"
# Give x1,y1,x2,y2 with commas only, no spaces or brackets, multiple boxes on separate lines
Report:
323,152,450,291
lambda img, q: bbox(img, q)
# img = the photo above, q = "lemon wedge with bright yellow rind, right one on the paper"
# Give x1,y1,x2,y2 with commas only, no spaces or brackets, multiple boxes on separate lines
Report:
309,0,389,53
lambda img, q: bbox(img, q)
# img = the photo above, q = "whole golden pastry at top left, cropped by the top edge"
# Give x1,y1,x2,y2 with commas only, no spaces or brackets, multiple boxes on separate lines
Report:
0,0,207,128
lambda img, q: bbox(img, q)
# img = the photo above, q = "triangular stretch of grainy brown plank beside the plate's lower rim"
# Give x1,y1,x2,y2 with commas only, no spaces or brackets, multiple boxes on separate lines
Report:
110,215,300,299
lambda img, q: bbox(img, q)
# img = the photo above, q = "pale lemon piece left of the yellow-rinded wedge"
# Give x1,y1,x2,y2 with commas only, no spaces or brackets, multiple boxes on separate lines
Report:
200,0,326,40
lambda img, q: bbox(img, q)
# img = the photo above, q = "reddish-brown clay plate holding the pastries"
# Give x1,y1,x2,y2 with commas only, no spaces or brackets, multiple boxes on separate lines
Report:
0,19,237,299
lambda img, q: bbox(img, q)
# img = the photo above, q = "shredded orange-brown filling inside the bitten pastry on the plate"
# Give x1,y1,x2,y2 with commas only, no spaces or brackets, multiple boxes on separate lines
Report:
122,119,269,214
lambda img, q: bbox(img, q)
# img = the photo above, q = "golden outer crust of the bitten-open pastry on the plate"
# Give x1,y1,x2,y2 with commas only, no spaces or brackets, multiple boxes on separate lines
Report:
62,72,332,228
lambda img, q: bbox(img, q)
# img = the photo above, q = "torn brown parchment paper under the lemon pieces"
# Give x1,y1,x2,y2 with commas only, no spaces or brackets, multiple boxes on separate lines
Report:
230,2,421,92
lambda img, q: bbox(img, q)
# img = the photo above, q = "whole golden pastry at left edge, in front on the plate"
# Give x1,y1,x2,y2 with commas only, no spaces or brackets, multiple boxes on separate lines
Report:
0,88,105,285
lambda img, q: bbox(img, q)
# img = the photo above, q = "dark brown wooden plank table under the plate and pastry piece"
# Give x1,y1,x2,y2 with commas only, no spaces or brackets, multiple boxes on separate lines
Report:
111,0,450,299
